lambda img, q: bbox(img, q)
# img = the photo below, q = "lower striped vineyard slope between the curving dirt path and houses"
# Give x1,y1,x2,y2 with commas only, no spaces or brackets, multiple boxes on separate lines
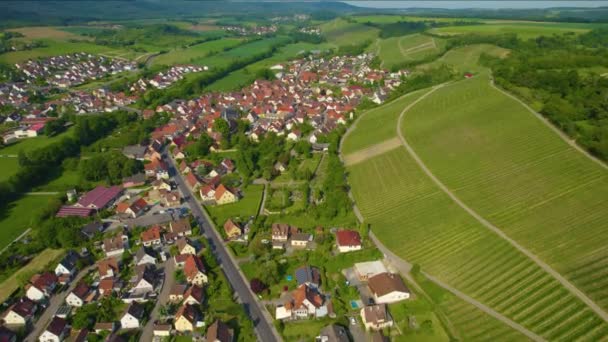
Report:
348,148,608,340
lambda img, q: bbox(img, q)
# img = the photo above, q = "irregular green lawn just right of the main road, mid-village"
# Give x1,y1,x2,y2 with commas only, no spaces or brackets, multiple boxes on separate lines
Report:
206,185,264,227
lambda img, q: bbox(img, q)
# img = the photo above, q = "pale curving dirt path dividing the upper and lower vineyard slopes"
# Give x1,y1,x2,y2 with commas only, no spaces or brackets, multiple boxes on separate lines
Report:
397,79,608,322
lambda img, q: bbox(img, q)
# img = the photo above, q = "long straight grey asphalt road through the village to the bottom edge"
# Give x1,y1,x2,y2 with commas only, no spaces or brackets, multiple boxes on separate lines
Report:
163,151,281,342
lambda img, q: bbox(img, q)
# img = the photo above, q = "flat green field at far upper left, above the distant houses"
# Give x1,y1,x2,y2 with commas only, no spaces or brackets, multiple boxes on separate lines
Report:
0,39,126,64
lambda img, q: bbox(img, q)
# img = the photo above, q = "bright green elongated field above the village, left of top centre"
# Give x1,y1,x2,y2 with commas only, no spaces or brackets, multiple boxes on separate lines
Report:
152,38,243,65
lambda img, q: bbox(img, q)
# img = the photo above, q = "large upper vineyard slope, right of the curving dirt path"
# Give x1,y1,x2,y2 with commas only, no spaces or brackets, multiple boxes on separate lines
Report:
403,77,608,308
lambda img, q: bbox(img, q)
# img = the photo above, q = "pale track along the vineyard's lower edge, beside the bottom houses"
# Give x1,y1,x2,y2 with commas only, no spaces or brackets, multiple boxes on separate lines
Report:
369,232,544,341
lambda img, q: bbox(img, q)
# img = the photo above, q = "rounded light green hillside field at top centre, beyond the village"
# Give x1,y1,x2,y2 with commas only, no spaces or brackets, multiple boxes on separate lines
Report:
320,19,378,46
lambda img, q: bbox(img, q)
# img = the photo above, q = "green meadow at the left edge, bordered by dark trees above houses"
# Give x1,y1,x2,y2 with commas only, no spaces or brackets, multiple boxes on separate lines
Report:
0,195,59,249
